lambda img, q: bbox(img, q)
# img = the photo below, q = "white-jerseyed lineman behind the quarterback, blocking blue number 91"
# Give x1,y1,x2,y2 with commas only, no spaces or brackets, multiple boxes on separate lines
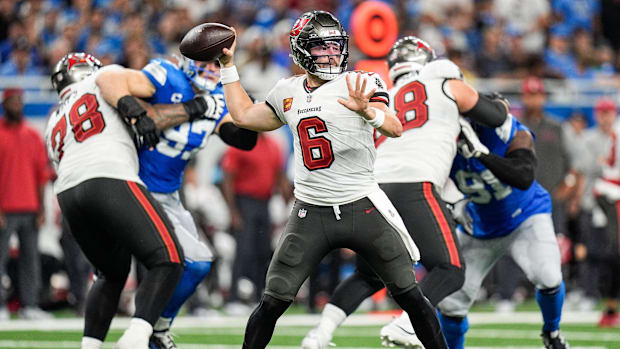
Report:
302,36,508,349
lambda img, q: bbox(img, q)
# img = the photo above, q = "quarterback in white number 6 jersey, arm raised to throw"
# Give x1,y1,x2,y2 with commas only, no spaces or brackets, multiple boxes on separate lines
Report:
212,11,446,349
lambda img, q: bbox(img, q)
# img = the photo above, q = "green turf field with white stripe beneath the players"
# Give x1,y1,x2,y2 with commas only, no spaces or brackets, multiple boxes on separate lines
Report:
0,313,620,349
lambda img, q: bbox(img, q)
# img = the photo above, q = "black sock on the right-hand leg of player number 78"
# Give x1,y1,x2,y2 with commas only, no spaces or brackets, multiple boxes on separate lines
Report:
134,263,183,324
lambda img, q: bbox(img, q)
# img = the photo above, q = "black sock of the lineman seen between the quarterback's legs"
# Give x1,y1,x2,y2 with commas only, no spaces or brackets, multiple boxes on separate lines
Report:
329,270,384,316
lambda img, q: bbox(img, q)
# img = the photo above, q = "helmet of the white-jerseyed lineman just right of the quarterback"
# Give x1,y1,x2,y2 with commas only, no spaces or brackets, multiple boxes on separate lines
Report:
387,36,436,82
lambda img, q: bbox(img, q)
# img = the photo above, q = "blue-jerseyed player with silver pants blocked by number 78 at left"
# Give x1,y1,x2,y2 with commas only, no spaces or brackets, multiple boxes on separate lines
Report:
98,57,257,349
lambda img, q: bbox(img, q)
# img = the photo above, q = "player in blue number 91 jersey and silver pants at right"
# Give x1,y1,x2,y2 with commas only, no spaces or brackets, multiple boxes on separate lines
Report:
438,115,568,349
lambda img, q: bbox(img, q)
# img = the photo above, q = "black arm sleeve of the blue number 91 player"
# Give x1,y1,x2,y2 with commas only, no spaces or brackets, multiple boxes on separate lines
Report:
480,149,536,190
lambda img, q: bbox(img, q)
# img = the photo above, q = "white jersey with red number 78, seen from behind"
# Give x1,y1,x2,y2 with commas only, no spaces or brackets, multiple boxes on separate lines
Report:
45,66,142,193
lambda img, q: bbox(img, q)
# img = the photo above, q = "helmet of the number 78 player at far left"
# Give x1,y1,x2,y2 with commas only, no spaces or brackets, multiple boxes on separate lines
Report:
51,52,101,94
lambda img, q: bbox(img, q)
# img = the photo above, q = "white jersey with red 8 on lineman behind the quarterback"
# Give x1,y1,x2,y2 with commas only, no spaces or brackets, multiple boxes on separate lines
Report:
375,59,463,188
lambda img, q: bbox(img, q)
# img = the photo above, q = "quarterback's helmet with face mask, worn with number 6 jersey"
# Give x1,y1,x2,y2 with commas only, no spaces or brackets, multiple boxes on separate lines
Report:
289,11,349,80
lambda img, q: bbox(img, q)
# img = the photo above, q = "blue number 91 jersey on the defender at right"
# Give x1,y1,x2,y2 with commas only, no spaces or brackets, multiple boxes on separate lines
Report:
450,114,551,238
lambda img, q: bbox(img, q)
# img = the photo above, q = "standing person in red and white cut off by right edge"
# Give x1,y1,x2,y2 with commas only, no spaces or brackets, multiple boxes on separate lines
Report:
594,98,620,327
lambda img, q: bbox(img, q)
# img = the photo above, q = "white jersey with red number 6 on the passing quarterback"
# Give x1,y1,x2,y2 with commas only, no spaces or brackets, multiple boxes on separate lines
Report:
266,72,389,206
